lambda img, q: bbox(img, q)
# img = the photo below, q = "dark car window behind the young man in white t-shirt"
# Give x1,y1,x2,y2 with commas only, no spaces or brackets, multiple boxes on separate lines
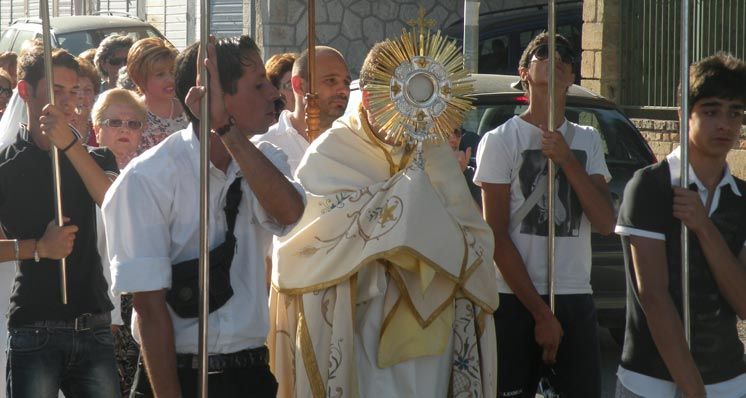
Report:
463,103,649,167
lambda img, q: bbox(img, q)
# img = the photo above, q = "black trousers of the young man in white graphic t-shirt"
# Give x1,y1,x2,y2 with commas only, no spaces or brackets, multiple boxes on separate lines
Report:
494,293,601,398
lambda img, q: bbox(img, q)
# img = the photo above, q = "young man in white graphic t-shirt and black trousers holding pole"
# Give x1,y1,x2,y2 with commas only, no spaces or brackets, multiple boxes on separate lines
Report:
474,33,614,397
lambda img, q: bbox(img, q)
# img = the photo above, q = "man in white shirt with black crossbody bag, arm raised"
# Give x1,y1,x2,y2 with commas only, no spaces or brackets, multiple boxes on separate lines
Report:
103,36,304,398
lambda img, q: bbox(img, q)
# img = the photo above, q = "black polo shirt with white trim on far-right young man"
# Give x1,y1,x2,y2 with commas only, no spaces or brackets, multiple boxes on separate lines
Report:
617,160,746,384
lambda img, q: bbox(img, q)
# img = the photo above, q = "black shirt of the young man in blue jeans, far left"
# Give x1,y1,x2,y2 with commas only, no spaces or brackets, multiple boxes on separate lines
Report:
0,128,118,327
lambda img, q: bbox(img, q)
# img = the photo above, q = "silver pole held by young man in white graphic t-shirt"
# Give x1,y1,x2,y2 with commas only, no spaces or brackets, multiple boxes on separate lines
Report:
547,0,557,312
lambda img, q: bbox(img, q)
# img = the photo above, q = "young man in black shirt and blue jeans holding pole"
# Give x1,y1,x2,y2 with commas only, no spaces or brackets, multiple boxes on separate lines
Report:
0,43,120,398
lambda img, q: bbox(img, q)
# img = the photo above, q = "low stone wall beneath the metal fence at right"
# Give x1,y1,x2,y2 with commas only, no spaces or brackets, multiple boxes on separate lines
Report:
632,119,746,179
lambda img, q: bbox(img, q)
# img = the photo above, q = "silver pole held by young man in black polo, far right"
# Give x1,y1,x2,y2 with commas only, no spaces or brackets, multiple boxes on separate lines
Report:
679,0,692,345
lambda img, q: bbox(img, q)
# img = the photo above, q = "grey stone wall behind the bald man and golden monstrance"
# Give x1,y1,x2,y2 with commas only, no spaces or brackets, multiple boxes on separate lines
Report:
257,0,546,78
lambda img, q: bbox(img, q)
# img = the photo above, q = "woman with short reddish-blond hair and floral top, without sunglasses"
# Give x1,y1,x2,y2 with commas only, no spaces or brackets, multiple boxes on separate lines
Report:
127,37,189,153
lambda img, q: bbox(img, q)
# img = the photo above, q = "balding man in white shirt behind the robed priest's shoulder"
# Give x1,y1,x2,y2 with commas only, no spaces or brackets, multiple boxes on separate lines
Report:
251,46,351,174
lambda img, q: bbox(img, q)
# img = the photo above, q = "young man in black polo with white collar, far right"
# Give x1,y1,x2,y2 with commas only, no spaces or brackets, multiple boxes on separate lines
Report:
616,53,746,398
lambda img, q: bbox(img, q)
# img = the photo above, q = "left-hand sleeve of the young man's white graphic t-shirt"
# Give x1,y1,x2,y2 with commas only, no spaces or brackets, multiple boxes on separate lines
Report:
474,122,515,186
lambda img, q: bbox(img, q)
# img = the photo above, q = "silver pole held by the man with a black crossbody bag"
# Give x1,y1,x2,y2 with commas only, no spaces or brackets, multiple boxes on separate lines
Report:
198,0,215,398
